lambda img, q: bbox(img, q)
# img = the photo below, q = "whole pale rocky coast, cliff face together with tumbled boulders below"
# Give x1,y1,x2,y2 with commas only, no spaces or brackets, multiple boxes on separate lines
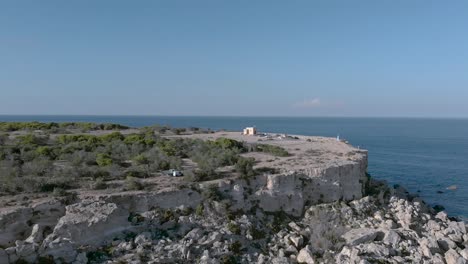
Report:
0,135,468,264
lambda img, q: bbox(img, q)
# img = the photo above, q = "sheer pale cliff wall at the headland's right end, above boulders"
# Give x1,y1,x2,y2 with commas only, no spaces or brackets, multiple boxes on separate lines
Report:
219,154,367,217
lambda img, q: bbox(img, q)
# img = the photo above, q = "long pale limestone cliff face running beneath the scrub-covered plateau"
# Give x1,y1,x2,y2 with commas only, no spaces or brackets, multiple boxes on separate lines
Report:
0,140,367,262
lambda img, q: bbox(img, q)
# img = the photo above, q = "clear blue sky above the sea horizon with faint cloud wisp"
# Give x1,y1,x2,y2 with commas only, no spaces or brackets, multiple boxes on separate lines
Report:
0,0,468,117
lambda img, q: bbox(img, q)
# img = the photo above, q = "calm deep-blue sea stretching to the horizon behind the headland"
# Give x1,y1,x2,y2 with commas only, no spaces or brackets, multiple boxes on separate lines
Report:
0,116,468,220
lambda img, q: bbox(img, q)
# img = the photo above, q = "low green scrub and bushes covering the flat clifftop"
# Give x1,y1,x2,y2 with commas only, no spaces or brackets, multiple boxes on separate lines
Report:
0,122,289,194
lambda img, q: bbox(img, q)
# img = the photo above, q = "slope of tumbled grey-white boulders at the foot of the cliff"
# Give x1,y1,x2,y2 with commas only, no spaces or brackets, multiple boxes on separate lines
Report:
0,180,468,264
